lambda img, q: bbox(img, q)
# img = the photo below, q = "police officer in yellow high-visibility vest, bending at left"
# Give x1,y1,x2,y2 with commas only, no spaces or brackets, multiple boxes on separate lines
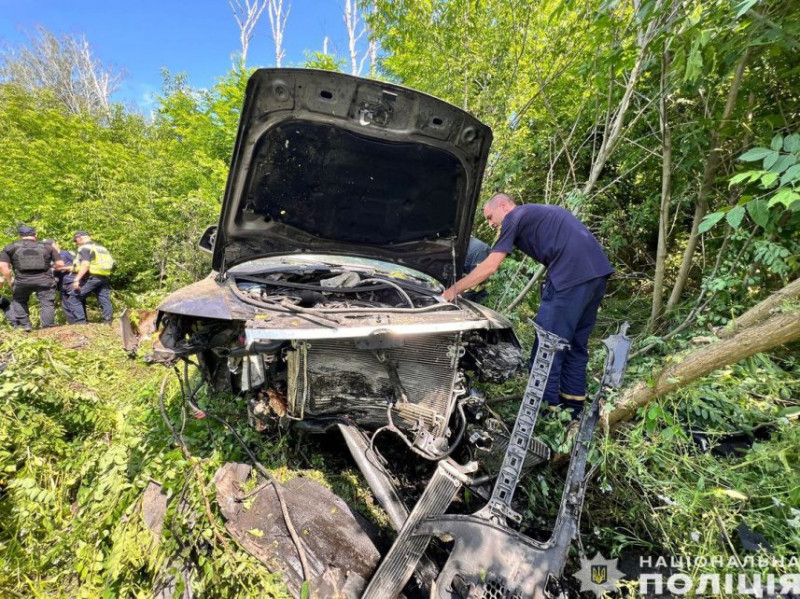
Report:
70,231,114,324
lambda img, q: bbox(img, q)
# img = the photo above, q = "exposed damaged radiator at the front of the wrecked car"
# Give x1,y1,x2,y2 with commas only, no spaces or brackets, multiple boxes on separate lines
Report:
287,333,462,436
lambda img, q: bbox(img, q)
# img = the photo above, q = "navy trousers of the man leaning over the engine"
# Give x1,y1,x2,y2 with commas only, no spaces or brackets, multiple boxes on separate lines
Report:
531,277,608,409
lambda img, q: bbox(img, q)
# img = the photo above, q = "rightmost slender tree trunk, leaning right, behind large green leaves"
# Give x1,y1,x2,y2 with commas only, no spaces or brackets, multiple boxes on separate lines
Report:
667,49,750,312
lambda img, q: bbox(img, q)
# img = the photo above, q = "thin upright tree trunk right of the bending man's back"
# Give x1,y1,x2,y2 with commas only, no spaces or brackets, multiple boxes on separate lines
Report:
647,50,672,329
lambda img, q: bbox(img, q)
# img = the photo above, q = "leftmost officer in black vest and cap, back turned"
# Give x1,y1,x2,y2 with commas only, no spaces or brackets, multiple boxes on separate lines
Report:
0,225,64,331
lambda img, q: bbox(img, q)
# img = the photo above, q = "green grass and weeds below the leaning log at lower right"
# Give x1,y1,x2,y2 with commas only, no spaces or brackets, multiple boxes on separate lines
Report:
588,356,800,564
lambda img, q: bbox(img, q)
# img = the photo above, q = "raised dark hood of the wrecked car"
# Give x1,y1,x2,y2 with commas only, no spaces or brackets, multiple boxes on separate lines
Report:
213,69,492,283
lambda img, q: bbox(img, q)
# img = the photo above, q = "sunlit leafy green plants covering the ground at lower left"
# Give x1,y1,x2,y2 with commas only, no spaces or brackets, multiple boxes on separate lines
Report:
0,326,288,597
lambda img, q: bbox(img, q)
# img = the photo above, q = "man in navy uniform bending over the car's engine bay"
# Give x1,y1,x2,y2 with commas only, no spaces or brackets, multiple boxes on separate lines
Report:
442,193,614,416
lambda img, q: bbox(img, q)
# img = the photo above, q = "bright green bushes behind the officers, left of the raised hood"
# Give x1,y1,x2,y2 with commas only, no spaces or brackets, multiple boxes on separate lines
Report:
0,71,248,301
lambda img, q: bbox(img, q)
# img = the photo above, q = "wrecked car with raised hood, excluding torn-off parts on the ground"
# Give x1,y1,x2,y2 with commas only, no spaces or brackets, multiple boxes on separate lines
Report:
152,69,524,457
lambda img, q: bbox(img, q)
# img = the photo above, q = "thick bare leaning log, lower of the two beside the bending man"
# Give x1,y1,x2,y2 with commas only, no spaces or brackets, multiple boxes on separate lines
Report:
603,310,800,428
